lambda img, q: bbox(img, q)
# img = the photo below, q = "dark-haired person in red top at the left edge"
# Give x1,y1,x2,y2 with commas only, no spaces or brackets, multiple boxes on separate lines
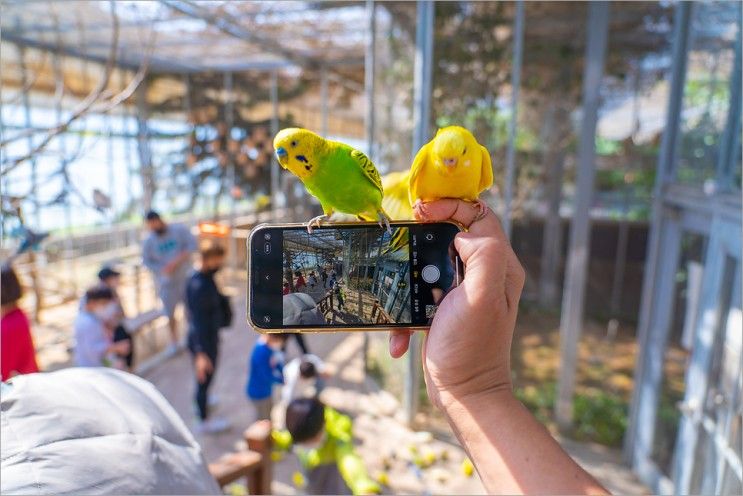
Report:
0,265,39,382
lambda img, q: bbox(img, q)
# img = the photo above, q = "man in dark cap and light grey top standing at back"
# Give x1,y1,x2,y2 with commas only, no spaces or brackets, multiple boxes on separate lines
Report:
142,210,197,354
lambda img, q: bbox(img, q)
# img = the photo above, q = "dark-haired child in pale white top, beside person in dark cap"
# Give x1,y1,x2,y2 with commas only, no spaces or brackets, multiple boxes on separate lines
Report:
74,286,131,367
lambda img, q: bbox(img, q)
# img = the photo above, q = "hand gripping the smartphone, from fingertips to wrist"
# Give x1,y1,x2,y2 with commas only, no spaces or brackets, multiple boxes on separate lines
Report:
389,199,525,409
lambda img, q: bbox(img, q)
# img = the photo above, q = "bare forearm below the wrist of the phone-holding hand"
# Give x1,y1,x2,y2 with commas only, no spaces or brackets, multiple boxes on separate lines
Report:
444,390,606,494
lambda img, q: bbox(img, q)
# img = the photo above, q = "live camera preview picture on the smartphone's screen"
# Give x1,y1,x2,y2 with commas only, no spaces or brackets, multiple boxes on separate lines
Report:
282,227,412,327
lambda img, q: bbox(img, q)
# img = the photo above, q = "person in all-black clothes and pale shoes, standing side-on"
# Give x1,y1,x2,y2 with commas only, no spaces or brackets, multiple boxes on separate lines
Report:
186,245,232,434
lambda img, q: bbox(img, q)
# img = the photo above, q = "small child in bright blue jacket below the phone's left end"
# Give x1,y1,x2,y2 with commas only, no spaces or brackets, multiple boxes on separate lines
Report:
245,334,289,420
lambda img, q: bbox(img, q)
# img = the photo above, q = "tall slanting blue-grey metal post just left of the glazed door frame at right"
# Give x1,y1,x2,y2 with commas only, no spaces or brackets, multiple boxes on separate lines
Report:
624,2,693,469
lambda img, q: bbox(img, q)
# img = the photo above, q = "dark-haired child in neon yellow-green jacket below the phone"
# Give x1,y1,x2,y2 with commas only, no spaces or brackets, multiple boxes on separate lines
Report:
271,398,380,494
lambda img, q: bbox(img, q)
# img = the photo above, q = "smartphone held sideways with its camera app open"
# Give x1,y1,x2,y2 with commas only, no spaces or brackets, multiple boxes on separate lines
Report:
248,221,464,332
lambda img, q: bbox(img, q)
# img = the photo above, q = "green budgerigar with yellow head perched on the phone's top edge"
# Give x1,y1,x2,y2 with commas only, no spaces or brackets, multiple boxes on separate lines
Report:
273,128,389,232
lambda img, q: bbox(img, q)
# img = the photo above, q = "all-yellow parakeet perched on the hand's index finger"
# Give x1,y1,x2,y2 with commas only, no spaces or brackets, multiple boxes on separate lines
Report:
409,126,493,212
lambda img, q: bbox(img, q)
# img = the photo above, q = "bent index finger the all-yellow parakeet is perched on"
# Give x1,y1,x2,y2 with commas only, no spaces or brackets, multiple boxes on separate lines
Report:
416,198,507,242
